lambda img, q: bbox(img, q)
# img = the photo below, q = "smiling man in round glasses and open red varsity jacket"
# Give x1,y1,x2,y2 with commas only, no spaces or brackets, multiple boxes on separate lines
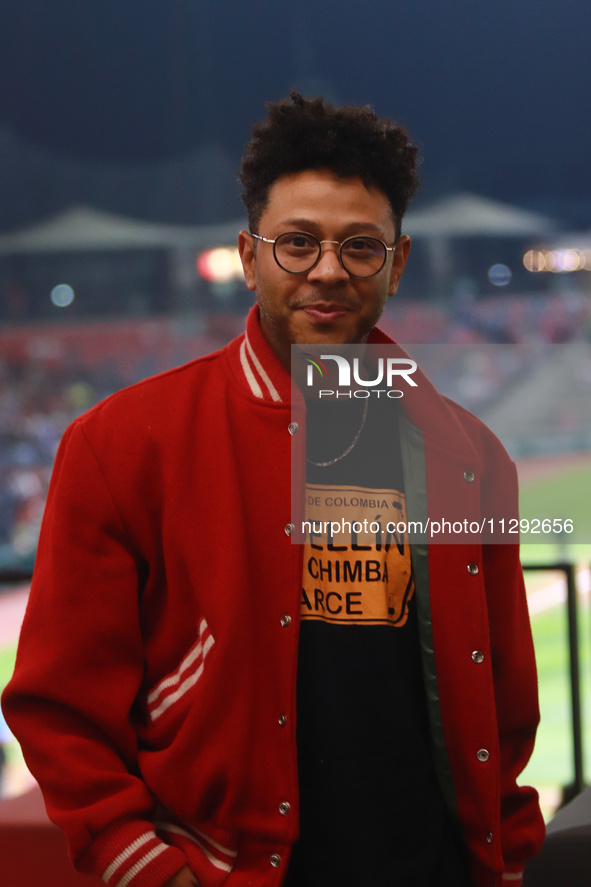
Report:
4,94,543,887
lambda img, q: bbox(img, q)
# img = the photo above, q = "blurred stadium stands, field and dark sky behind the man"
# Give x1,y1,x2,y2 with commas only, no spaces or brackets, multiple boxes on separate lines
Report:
0,0,591,840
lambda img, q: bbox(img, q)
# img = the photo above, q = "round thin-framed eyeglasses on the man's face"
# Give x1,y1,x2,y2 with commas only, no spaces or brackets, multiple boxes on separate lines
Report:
251,231,396,279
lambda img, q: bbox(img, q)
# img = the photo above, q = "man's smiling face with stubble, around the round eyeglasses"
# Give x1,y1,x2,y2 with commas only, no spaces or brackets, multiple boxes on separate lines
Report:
239,170,410,369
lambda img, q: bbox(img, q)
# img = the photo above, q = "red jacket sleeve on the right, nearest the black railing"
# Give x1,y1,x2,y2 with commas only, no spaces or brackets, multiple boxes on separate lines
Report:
484,462,545,885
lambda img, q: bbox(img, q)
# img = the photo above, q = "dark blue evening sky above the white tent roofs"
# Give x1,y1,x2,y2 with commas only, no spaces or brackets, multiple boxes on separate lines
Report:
0,0,591,230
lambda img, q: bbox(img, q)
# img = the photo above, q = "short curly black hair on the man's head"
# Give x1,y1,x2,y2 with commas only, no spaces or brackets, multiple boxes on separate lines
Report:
239,92,420,239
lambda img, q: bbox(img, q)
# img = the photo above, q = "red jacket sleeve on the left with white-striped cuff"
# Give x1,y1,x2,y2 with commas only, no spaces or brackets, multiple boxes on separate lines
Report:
3,422,186,887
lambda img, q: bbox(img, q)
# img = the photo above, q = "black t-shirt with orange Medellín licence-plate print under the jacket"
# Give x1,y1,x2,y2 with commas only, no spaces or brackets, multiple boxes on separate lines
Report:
286,400,468,887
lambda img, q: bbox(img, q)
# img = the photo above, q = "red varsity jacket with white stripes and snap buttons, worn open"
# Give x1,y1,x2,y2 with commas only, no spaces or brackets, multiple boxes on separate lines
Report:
3,308,543,887
